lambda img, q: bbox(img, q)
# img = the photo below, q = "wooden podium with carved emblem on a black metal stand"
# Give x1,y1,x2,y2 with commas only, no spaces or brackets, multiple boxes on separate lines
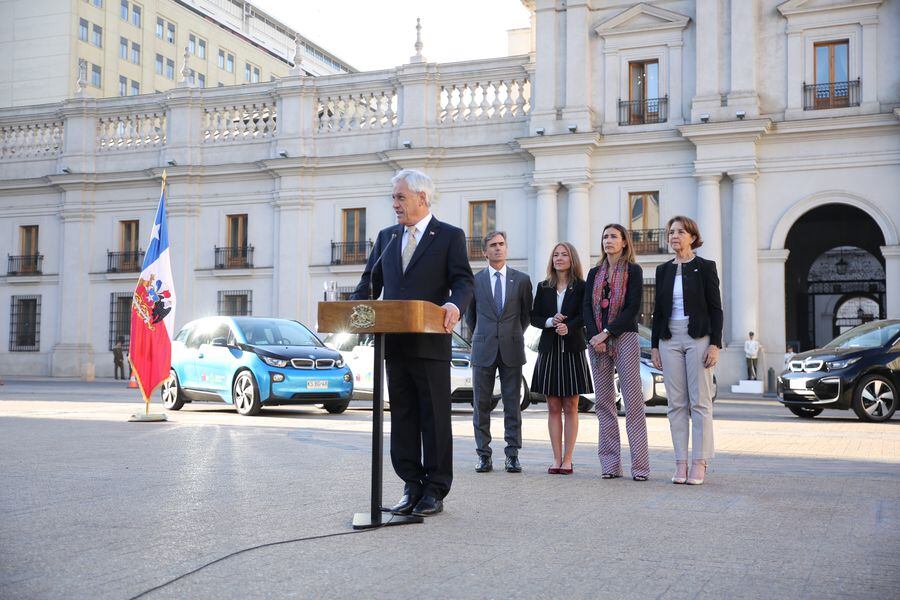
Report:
318,300,446,529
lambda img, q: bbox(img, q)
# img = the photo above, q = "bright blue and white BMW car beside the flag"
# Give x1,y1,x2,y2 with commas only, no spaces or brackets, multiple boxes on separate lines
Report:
160,317,353,415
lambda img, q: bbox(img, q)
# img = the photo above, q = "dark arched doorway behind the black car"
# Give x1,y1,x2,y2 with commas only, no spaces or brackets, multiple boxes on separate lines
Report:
785,204,885,350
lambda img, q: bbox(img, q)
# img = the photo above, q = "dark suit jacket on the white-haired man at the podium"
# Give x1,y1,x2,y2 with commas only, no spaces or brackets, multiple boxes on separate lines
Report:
351,215,473,361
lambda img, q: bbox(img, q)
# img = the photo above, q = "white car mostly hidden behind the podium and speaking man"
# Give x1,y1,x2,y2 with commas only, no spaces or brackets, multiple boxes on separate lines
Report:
324,332,500,408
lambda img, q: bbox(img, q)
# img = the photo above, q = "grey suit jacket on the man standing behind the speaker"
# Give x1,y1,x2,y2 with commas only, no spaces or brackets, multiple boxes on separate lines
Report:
466,265,531,367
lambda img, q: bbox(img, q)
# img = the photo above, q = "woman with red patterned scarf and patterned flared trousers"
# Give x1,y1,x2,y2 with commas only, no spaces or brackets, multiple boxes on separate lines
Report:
583,223,650,481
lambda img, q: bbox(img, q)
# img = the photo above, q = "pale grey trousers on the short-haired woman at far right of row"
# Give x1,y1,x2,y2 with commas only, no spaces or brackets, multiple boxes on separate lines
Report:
659,319,714,460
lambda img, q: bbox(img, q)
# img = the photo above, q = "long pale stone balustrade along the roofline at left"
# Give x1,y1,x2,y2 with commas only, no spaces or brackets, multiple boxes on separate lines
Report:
0,56,532,178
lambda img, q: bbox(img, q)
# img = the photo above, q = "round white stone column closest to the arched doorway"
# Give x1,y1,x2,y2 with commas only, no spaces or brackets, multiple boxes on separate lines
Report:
730,173,760,344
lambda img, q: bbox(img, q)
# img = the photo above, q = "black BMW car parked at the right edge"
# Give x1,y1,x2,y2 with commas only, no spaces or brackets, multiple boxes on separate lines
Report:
778,319,900,421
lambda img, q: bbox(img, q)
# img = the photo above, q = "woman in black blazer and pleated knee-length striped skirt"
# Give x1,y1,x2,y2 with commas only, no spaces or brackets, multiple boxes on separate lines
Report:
531,242,593,475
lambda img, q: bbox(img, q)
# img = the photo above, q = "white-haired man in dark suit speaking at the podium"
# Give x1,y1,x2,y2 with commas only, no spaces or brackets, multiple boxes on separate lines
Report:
352,169,474,516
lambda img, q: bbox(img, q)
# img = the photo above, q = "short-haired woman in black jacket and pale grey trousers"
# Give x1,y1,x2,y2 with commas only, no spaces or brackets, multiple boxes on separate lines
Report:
651,216,724,485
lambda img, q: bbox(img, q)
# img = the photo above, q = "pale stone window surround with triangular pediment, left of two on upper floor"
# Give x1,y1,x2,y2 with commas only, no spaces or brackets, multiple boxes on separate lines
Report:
594,3,691,133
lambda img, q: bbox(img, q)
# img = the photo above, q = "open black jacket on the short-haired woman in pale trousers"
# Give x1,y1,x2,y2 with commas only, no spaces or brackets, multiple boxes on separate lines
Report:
651,256,724,348
